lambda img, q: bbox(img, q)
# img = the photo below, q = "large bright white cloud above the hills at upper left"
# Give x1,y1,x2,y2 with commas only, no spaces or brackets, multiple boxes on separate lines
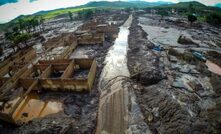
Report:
0,0,93,22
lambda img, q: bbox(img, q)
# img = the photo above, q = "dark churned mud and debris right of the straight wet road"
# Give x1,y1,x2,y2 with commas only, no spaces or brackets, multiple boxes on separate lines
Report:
127,15,221,134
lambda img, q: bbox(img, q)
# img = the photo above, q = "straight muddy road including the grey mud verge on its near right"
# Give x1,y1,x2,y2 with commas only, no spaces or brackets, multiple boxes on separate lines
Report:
96,15,149,134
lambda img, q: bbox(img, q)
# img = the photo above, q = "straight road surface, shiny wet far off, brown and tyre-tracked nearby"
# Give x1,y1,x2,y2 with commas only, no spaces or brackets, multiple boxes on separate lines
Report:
96,16,132,134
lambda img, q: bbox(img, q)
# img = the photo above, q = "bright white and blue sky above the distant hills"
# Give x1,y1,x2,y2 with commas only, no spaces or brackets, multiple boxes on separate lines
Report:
0,0,221,23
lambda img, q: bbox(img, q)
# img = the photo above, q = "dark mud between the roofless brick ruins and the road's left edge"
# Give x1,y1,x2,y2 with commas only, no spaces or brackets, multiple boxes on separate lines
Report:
0,11,127,134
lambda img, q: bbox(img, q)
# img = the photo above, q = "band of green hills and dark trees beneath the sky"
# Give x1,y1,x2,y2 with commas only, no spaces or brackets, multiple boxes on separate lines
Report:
0,1,221,31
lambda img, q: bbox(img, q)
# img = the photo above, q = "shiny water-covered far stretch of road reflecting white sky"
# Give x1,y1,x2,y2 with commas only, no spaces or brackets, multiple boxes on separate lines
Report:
101,16,132,87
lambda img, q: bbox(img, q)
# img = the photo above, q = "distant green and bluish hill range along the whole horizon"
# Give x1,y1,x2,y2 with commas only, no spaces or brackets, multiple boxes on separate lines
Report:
0,0,221,30
